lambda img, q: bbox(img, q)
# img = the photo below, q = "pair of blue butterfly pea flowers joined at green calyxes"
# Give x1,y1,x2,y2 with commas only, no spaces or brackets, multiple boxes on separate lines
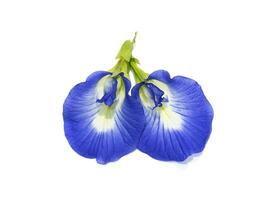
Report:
63,34,213,164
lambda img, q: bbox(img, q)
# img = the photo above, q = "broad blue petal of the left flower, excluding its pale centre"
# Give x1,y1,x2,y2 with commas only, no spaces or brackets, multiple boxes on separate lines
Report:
63,72,144,164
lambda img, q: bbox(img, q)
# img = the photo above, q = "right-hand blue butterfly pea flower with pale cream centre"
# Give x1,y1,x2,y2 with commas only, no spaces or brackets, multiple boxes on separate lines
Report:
132,69,213,161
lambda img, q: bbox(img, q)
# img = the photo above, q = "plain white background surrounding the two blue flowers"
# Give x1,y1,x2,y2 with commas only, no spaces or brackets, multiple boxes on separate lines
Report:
0,0,267,200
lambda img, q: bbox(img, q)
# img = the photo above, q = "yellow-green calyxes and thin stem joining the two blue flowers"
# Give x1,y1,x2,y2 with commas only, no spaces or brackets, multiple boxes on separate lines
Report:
109,33,148,83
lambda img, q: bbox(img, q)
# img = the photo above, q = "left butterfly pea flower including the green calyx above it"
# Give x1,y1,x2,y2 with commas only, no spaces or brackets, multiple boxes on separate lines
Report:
63,36,144,164
